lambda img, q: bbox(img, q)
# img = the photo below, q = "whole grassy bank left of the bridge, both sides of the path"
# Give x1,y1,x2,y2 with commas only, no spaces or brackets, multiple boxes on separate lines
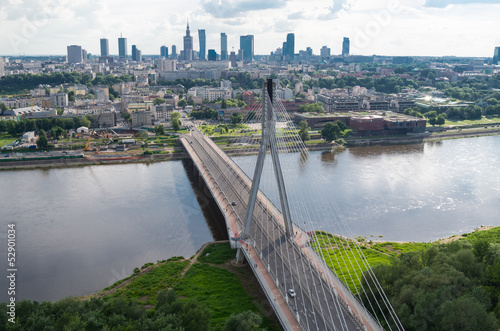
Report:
98,244,281,331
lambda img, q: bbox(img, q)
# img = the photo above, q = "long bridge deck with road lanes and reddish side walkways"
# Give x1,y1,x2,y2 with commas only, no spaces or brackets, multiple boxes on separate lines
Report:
181,129,381,330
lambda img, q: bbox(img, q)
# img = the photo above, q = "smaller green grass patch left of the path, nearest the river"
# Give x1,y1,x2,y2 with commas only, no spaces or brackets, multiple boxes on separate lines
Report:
111,261,188,305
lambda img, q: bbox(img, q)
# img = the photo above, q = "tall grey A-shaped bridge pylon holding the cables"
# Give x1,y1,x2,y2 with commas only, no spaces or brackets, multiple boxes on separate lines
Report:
243,79,293,243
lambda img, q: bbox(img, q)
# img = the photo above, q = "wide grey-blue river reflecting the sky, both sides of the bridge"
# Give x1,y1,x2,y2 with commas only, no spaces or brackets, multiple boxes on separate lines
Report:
0,136,500,301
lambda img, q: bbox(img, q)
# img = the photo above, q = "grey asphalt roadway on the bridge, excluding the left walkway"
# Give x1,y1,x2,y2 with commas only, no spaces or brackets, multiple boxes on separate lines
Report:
183,128,378,330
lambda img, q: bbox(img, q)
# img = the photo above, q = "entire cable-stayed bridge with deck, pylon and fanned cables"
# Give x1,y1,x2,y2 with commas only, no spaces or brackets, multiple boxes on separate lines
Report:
181,80,403,330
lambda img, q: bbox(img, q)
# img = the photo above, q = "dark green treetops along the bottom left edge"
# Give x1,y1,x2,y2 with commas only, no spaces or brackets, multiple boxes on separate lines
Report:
0,290,262,331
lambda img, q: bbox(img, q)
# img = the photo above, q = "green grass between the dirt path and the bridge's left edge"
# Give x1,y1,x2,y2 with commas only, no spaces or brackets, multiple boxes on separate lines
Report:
174,263,279,330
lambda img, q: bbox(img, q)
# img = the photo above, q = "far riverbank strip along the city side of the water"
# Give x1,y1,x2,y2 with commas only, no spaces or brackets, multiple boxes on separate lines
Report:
0,128,500,171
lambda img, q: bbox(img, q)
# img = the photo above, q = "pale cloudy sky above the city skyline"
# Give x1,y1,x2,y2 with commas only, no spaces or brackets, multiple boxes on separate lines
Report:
0,0,500,57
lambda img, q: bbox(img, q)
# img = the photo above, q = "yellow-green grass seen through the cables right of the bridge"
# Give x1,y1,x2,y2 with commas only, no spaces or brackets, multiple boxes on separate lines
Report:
311,231,394,293
